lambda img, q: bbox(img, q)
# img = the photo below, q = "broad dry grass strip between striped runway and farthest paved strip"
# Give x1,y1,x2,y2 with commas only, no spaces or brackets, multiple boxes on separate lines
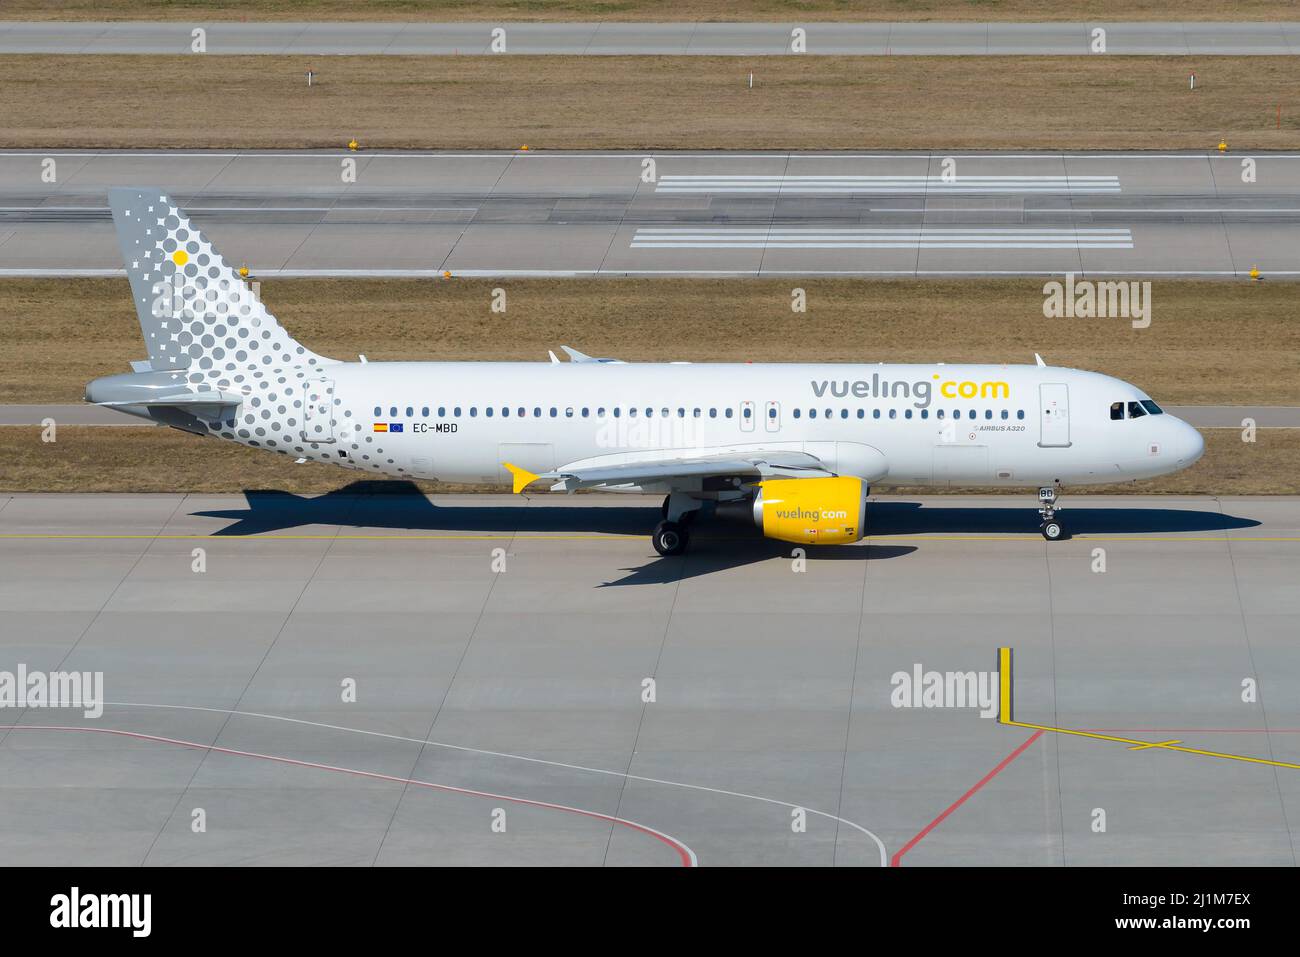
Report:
0,56,1300,150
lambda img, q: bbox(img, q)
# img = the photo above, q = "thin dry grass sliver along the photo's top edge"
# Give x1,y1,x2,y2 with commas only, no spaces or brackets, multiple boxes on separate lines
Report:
0,0,1295,22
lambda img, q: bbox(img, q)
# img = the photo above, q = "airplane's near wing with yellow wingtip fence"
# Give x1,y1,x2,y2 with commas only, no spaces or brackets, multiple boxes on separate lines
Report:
502,446,888,493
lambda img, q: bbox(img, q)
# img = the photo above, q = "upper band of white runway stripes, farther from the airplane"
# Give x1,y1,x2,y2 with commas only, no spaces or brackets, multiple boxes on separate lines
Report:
655,174,1122,195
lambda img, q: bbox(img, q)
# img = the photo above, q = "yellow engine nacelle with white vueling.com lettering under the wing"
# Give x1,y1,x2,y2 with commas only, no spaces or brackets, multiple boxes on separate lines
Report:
754,476,867,545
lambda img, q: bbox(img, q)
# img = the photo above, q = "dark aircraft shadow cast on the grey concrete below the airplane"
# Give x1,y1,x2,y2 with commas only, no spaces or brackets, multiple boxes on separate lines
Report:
194,481,1260,586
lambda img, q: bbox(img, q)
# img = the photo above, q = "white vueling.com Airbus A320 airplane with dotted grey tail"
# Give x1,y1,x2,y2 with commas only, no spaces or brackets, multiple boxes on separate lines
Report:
86,189,1205,555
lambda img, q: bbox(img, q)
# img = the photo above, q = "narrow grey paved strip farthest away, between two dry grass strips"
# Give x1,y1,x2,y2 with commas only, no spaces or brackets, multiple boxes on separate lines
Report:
0,20,1300,56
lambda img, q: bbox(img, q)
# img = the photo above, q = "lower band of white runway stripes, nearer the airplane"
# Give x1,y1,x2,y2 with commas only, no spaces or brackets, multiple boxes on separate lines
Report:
632,226,1134,250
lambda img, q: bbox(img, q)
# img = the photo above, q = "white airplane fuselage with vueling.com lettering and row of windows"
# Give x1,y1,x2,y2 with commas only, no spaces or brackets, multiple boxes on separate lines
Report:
269,361,1204,490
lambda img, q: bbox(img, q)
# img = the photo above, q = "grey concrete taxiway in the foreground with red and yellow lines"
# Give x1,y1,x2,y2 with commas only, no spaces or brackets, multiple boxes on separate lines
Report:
0,494,1300,866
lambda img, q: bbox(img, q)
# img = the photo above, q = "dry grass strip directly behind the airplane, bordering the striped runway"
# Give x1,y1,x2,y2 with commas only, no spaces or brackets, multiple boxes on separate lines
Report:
0,278,1300,406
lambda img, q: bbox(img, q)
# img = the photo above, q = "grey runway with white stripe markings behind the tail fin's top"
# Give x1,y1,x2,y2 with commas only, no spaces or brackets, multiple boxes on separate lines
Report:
0,151,1300,280
